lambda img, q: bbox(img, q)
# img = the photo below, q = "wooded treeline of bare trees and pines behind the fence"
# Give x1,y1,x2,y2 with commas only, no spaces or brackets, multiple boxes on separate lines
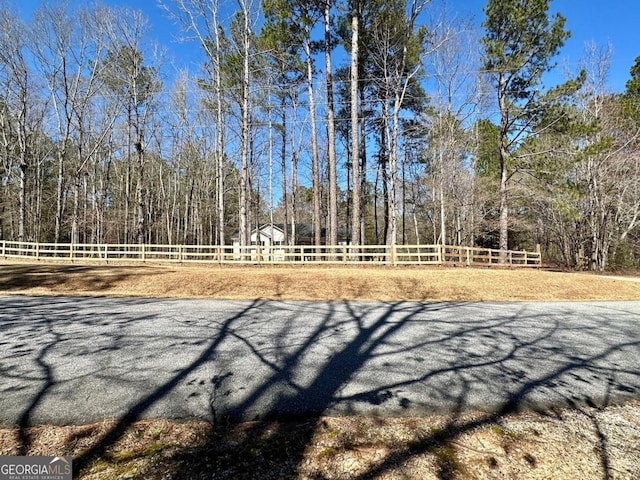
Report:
0,0,640,269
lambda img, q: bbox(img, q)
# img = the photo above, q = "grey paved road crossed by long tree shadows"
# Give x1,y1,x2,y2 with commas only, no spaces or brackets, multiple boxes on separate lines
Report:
0,297,640,426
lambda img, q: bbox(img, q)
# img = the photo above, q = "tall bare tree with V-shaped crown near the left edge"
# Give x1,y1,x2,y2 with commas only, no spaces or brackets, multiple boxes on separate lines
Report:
32,5,117,242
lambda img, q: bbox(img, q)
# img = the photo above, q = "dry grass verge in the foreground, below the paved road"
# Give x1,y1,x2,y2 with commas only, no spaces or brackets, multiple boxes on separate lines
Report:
0,402,640,480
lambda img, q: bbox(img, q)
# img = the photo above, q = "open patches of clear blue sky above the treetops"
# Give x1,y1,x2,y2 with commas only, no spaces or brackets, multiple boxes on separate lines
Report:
19,0,640,92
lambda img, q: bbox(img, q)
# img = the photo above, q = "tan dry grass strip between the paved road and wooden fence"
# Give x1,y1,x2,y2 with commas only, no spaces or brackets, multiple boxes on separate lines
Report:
0,263,640,302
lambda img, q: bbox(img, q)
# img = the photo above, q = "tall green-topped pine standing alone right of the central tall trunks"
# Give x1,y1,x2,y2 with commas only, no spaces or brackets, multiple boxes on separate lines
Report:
483,0,570,252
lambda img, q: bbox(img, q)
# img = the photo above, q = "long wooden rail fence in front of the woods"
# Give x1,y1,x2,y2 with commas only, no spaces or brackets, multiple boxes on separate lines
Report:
0,240,542,267
